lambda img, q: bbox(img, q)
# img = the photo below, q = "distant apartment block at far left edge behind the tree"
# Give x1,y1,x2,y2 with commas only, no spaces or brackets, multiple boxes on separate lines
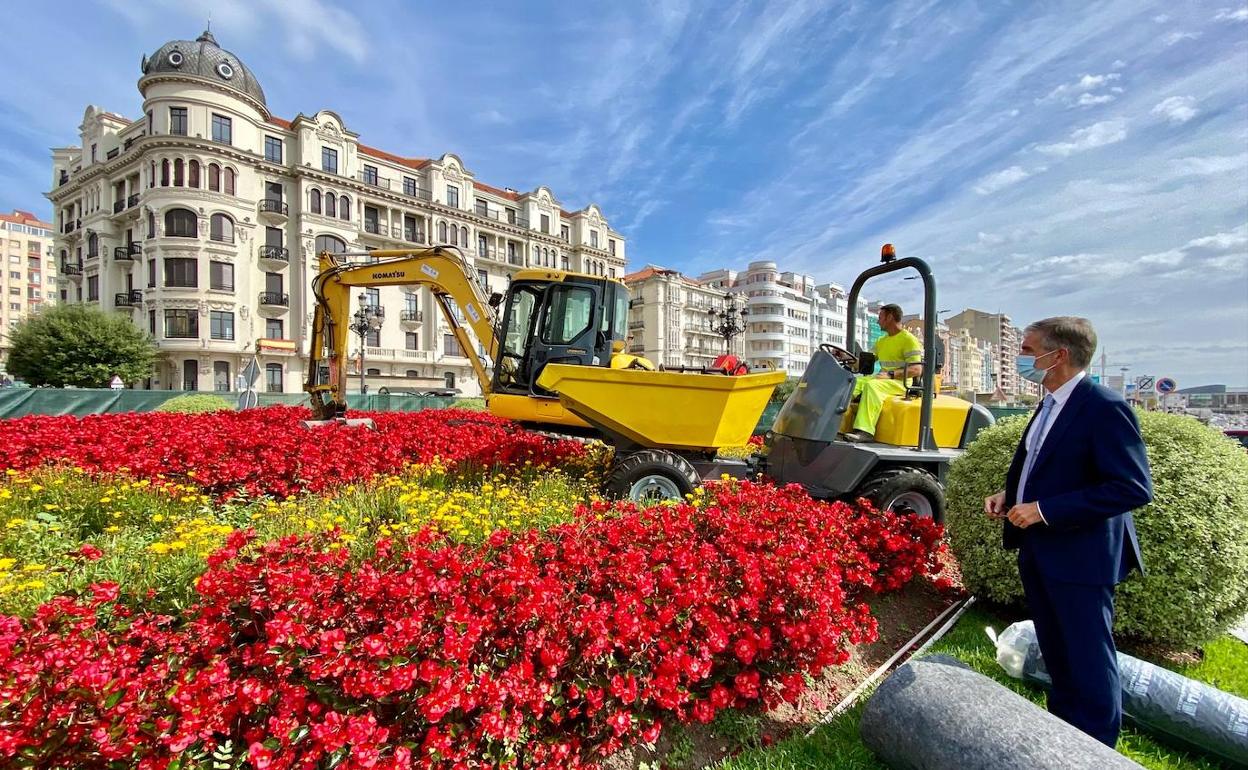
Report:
0,210,56,367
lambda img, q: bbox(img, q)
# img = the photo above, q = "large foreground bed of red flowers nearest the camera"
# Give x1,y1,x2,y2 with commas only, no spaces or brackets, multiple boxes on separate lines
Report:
0,483,938,769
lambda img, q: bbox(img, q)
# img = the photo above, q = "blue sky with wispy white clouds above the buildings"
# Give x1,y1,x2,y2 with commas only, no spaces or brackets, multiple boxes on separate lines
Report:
0,0,1248,386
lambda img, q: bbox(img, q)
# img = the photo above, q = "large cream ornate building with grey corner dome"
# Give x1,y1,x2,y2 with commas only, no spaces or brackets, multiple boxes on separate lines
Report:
47,32,625,394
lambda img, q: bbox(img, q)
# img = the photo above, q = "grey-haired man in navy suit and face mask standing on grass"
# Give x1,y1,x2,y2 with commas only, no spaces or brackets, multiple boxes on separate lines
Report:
983,317,1153,746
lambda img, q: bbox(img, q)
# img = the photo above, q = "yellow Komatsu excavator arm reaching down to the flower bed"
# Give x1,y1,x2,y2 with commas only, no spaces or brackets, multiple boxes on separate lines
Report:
305,246,498,421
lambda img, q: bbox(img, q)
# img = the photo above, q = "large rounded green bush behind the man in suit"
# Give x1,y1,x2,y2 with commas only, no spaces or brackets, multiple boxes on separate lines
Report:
946,412,1248,645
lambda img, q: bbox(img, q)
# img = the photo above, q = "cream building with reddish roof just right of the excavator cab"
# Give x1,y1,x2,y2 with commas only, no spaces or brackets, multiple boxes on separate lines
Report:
624,266,728,368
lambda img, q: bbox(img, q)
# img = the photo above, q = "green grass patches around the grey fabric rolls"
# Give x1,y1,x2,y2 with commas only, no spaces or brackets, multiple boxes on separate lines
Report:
719,608,1248,770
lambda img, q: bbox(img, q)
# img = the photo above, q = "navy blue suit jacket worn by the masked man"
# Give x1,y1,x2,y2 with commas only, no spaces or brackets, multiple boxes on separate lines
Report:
1005,377,1153,585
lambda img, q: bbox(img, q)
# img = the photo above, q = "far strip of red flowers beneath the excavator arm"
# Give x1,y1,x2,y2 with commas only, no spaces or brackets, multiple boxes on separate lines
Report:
0,407,582,495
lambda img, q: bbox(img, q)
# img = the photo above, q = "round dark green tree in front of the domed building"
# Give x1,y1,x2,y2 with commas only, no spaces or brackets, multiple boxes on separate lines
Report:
7,305,156,388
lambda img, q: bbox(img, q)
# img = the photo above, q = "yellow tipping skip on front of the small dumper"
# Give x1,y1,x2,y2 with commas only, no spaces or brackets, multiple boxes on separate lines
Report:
538,363,785,452
